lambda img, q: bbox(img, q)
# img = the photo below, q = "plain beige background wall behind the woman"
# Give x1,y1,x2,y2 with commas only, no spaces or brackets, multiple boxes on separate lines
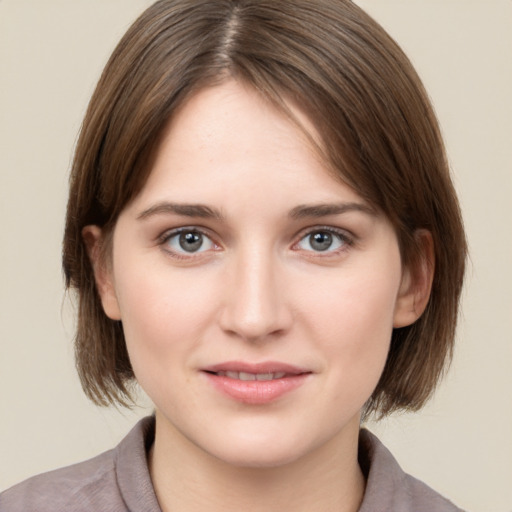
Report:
0,0,512,512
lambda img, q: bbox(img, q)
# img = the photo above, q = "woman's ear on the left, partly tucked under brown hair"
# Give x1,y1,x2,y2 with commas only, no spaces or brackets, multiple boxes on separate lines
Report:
82,225,121,320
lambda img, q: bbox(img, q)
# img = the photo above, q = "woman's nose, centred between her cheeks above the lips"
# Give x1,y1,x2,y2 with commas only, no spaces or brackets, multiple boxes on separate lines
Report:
220,248,292,342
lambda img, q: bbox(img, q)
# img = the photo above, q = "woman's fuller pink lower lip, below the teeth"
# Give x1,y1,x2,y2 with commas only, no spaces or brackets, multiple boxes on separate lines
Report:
205,372,311,405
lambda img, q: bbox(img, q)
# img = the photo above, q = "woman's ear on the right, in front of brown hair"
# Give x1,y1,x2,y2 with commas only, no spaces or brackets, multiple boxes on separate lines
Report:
393,229,435,327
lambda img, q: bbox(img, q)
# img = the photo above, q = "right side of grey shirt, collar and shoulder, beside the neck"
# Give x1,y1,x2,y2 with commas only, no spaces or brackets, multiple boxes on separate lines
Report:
359,429,462,512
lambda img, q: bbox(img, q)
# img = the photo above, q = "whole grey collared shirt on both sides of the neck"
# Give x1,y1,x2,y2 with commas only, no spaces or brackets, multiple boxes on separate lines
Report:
0,417,461,512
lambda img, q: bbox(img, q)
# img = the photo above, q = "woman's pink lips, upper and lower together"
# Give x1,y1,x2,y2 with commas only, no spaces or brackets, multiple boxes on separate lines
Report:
201,361,313,405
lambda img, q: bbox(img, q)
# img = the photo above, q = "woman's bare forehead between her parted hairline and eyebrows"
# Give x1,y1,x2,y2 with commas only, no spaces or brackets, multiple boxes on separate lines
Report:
130,81,366,211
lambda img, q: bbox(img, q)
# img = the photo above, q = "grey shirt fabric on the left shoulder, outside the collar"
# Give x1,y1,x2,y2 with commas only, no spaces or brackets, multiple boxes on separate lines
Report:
0,450,123,512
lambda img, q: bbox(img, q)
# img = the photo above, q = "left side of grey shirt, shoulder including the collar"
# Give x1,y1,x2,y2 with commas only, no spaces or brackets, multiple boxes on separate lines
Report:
0,417,160,512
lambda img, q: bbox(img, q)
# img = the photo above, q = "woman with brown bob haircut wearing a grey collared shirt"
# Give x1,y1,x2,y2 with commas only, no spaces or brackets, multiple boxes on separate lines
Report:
0,0,466,512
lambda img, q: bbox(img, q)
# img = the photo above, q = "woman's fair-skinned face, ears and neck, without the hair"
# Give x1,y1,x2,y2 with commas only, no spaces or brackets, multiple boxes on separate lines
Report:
84,81,431,512
